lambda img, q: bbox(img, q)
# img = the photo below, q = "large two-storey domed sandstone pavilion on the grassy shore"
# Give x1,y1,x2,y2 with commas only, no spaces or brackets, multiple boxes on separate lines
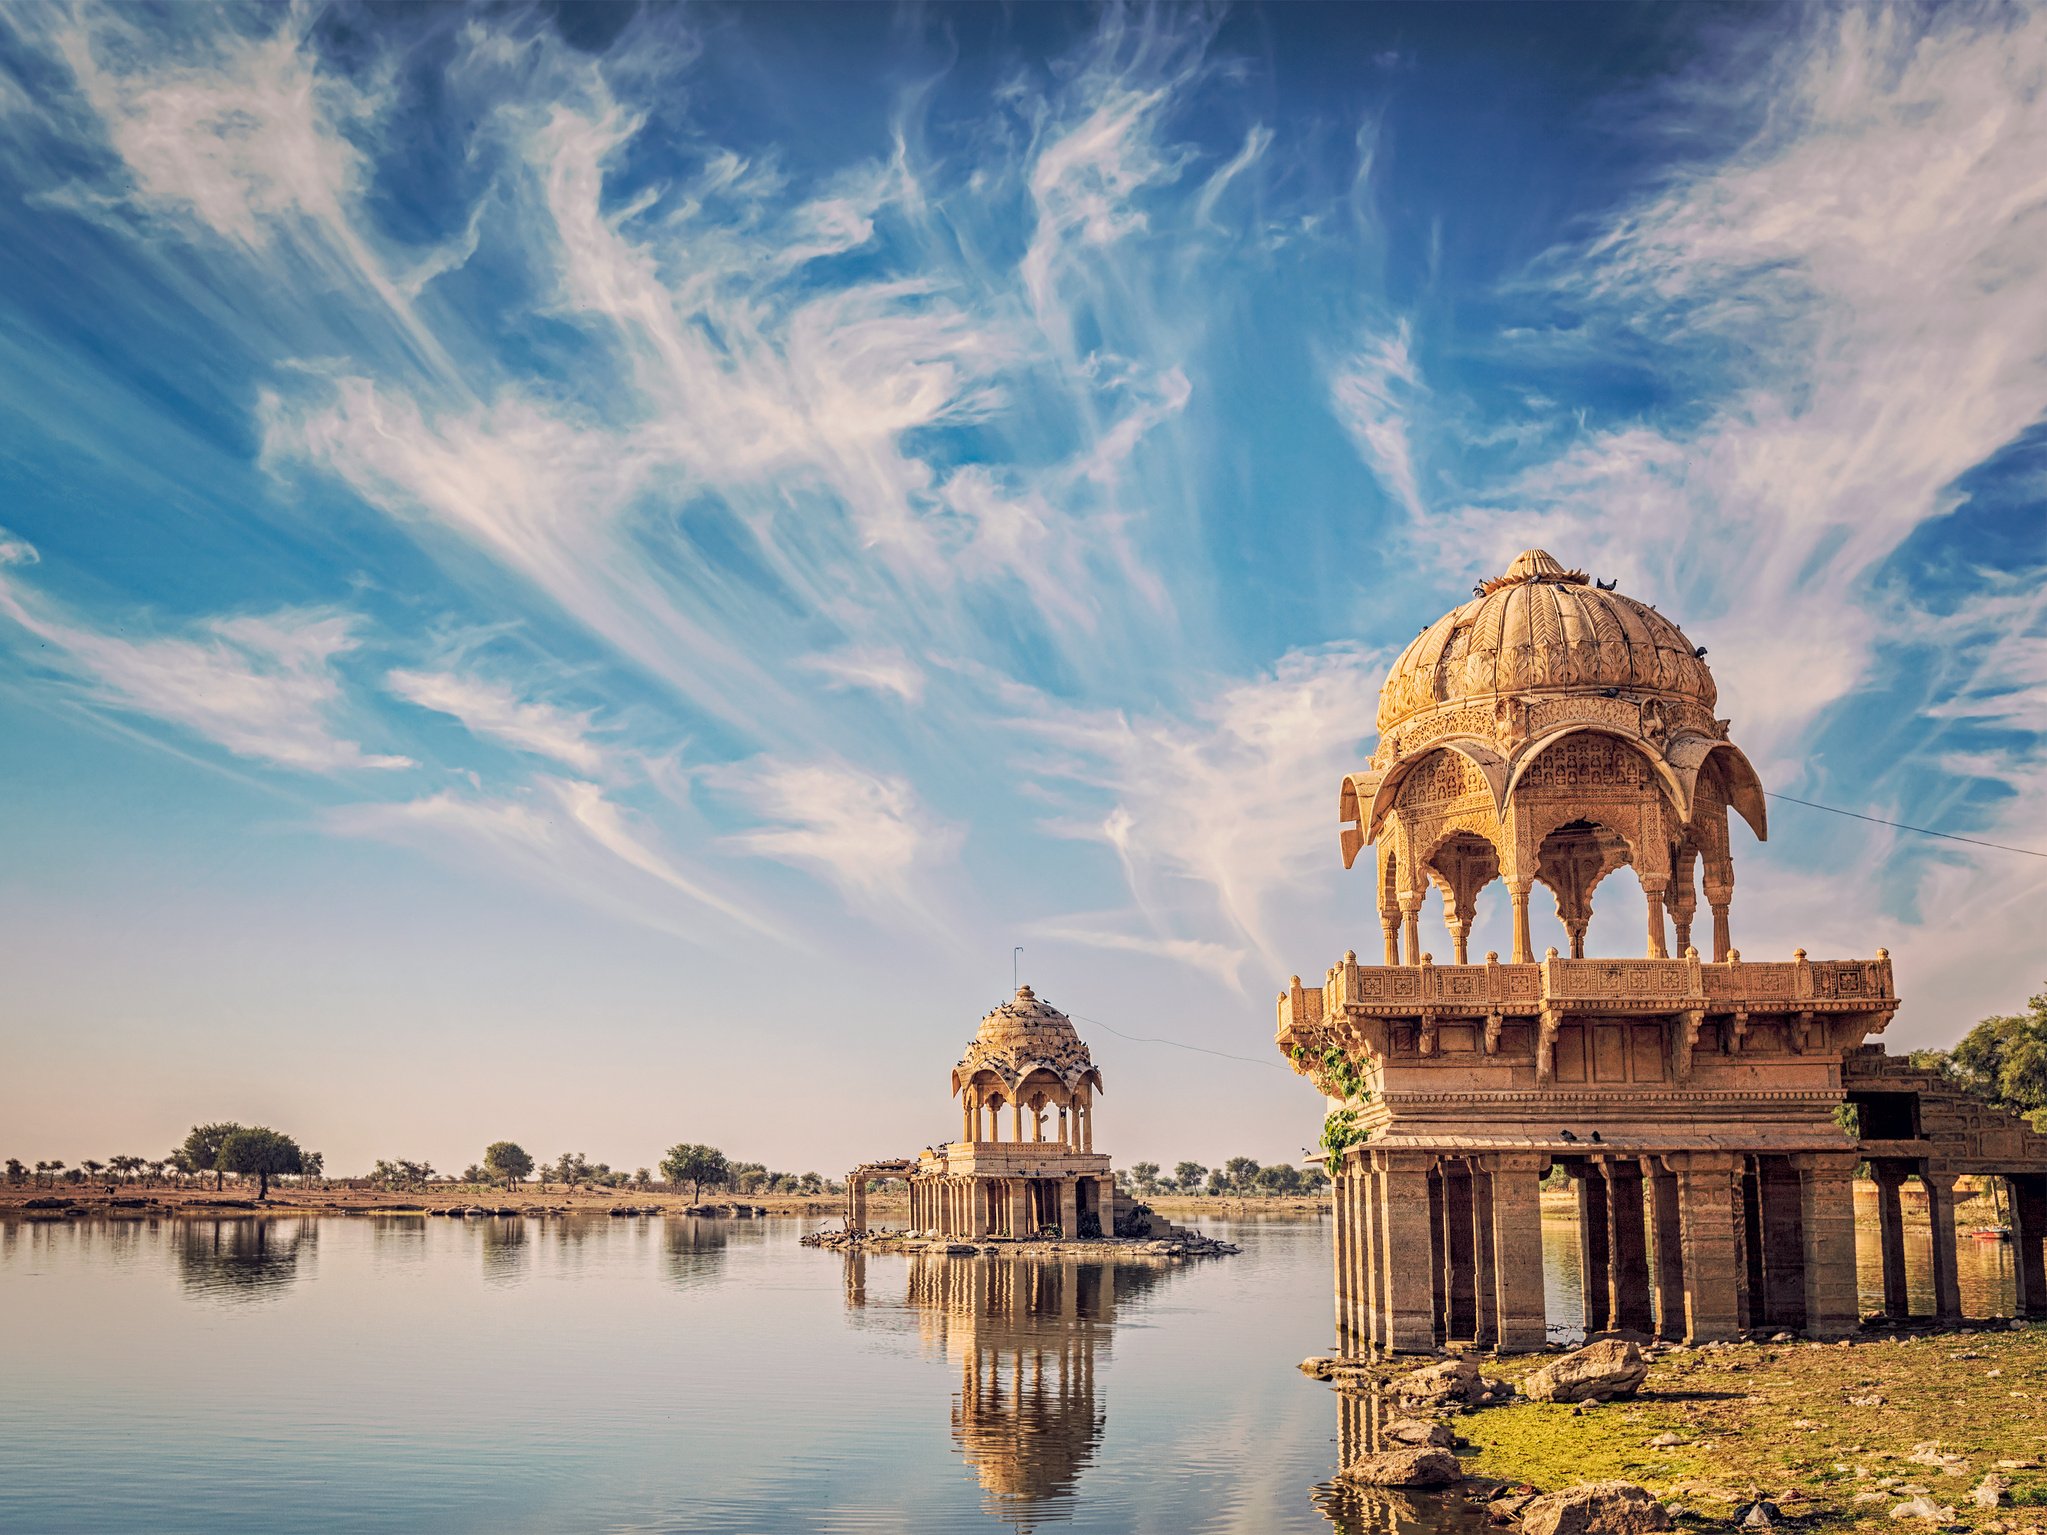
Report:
1279,549,2047,1355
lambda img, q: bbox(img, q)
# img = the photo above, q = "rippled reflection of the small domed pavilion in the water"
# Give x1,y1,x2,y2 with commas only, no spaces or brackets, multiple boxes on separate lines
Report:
845,1253,1171,1529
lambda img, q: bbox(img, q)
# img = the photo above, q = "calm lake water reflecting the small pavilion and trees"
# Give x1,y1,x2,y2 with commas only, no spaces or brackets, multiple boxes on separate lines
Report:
0,1216,2008,1535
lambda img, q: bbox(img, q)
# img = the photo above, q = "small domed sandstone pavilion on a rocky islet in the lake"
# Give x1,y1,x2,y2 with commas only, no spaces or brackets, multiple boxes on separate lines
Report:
845,986,1116,1240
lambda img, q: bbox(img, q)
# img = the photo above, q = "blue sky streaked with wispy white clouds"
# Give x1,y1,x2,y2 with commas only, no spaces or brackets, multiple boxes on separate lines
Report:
0,6,2047,1171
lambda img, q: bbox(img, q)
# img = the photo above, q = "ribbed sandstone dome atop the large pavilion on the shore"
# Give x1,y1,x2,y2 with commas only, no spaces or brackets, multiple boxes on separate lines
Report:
1380,549,1719,733
